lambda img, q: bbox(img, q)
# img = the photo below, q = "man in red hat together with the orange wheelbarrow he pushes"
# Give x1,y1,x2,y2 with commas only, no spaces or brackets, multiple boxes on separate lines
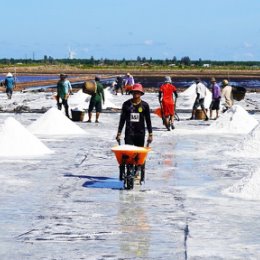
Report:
112,84,153,189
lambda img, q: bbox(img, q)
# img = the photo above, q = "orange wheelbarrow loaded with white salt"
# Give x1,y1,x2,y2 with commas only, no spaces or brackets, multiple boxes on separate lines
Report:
112,145,151,190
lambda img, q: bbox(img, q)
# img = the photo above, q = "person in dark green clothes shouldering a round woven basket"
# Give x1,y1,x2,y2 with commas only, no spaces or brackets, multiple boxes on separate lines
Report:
87,76,105,123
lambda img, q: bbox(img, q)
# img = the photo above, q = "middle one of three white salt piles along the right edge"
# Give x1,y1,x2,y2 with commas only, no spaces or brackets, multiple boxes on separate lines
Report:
227,124,260,158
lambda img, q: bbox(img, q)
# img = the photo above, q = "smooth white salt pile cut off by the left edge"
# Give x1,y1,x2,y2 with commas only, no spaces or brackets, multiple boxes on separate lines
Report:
0,117,52,157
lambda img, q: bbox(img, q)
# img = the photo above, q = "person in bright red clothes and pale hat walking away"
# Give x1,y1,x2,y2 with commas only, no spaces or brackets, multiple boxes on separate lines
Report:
159,76,178,131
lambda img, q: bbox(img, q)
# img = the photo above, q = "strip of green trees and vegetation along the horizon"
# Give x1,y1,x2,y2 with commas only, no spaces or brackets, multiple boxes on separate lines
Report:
0,56,260,70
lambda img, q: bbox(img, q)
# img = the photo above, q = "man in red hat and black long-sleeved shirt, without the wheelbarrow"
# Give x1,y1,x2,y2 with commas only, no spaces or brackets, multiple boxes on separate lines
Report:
116,84,153,182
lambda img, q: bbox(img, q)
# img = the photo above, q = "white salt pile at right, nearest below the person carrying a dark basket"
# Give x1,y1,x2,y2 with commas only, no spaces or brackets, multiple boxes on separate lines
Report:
207,105,258,134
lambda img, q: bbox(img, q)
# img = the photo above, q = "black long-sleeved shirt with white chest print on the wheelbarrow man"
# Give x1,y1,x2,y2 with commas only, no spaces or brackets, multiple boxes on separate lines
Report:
118,99,152,136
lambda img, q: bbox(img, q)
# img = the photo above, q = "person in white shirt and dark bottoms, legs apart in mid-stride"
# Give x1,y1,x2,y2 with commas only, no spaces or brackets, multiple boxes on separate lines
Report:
190,78,209,121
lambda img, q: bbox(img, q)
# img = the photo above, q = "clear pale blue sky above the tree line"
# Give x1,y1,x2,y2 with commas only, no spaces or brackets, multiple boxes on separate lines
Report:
0,0,260,61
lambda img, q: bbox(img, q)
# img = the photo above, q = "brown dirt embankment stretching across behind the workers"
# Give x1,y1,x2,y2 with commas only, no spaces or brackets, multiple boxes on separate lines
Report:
0,65,260,90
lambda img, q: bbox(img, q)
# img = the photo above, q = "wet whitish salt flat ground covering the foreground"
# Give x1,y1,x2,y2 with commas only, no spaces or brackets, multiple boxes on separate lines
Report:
0,88,260,260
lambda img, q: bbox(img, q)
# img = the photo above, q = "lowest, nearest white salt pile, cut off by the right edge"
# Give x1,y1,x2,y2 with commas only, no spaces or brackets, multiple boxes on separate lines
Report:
222,169,260,200
